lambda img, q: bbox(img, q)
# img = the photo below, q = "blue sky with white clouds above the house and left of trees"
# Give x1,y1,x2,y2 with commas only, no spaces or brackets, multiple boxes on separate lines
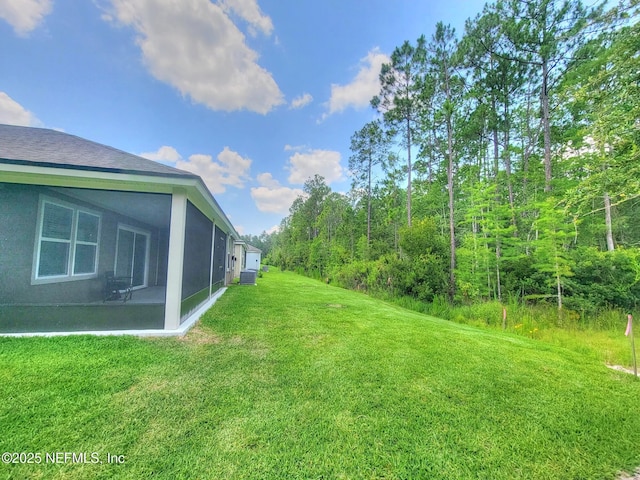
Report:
0,0,485,234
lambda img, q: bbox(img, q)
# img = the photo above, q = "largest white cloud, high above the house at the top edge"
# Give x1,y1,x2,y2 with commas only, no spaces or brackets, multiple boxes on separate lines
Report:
105,0,284,114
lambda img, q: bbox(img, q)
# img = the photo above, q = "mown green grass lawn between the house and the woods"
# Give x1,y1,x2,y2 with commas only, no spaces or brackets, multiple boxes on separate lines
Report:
0,271,640,480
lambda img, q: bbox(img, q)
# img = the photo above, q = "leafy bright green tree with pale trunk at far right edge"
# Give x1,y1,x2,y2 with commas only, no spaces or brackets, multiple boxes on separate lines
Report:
563,2,640,251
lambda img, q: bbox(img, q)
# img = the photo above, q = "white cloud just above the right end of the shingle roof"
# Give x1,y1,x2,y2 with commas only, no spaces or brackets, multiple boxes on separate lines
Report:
140,146,251,195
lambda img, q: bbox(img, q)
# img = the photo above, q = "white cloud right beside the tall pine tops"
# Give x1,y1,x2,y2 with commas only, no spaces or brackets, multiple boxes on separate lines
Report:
323,47,390,119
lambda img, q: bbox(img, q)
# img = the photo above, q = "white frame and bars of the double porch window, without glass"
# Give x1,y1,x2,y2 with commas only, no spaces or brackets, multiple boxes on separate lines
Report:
31,195,102,285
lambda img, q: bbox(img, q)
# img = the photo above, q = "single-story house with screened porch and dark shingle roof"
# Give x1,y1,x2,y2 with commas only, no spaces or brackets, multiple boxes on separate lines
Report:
0,125,240,334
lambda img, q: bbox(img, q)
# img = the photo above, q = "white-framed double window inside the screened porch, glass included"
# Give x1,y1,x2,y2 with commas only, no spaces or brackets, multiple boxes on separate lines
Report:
33,198,100,283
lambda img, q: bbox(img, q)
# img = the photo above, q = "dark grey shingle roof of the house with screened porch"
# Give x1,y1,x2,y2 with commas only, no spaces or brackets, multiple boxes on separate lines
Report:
0,125,197,177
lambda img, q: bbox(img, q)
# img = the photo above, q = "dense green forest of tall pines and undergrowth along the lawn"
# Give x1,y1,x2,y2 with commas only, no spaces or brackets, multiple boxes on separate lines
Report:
256,0,640,317
